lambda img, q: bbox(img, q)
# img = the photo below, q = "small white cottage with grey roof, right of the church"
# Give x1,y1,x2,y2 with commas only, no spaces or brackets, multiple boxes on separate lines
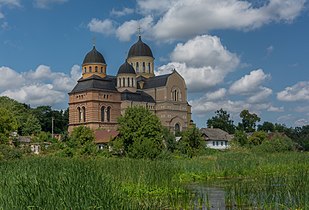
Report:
201,128,232,149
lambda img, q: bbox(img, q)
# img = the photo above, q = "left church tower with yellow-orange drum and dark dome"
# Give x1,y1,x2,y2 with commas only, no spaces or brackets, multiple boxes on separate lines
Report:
82,46,106,79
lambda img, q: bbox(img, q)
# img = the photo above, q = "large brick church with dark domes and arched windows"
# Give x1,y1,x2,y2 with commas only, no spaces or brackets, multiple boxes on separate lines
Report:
69,35,192,135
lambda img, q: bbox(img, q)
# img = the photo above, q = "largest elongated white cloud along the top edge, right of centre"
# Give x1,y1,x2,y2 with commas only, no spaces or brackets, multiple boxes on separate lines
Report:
150,0,305,40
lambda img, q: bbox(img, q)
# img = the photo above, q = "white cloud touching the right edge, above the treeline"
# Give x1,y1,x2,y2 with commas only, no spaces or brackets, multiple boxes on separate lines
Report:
277,81,309,102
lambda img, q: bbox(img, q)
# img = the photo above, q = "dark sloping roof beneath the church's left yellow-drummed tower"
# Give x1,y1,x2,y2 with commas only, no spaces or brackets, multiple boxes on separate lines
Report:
70,74,117,93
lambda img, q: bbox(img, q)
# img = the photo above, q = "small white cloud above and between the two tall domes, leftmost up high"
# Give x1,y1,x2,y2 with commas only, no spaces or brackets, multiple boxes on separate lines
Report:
87,18,115,35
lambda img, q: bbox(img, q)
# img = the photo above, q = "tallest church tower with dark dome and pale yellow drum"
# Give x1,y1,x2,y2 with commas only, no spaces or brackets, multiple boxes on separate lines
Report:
127,35,154,78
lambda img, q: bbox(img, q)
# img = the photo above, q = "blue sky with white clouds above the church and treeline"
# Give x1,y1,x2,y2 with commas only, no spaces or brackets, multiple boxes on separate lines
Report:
0,0,309,127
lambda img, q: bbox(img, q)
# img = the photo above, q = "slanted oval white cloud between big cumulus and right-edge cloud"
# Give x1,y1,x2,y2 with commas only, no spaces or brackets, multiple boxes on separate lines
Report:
229,69,270,94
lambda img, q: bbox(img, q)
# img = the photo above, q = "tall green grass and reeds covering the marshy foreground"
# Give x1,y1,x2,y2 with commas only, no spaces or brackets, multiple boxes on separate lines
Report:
0,151,309,209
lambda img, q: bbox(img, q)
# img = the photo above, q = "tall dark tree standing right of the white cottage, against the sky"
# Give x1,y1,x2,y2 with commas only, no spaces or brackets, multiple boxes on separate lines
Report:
238,109,261,132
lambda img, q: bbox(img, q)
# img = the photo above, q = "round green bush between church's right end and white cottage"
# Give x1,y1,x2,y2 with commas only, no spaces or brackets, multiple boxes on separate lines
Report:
178,126,205,157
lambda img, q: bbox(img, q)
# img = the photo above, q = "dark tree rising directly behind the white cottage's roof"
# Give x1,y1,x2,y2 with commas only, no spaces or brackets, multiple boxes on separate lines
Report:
207,109,235,134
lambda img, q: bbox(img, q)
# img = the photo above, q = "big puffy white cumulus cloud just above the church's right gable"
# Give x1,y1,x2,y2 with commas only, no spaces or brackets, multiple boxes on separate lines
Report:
156,35,240,92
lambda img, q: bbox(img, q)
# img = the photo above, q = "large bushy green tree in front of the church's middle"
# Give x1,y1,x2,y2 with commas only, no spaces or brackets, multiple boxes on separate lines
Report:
117,107,163,159
